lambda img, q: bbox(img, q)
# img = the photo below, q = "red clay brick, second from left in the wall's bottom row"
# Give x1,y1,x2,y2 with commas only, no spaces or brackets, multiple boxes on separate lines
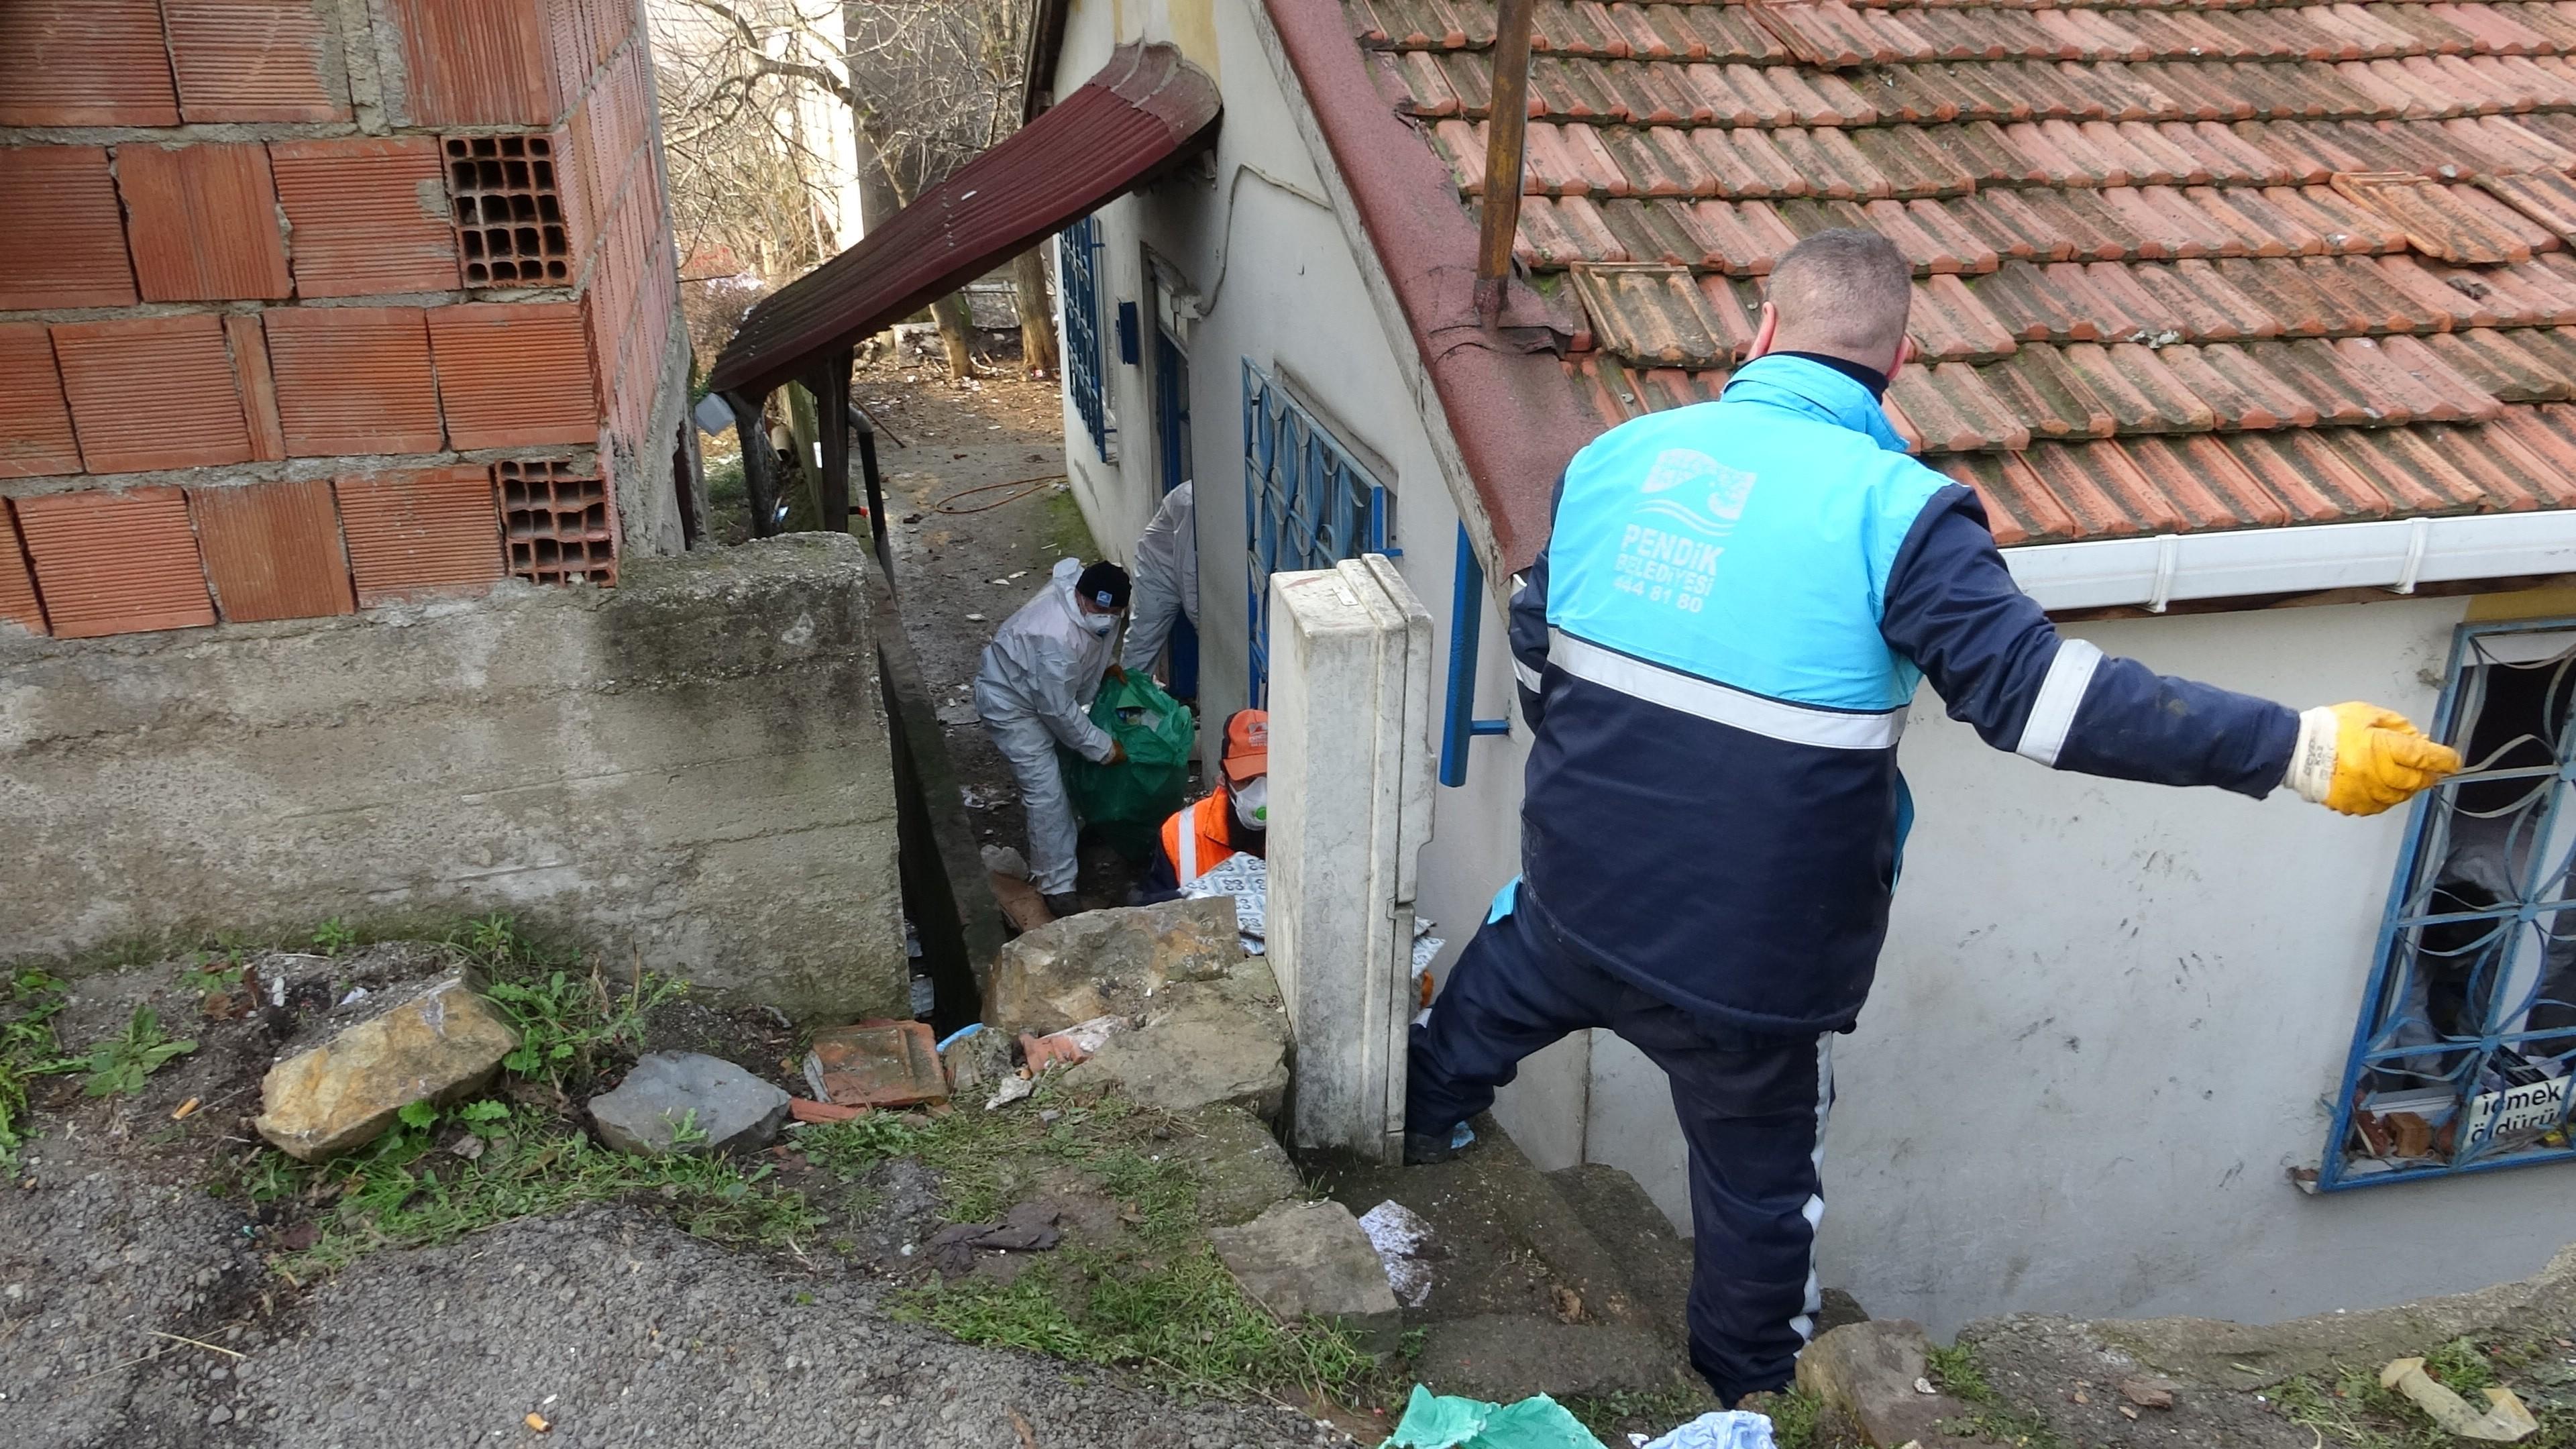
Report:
15,487,214,639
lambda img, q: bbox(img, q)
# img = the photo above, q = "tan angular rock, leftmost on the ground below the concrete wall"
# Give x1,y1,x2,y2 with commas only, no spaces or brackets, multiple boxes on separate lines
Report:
255,972,518,1163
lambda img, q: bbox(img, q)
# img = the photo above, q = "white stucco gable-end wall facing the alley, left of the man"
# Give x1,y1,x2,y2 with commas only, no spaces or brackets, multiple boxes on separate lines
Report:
1056,0,1587,1168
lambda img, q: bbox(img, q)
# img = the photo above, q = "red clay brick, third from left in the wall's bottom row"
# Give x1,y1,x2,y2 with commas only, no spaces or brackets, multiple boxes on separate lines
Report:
188,477,358,624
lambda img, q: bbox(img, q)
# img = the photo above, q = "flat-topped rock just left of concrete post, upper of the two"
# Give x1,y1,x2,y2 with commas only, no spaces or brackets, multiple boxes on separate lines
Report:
984,898,1244,1036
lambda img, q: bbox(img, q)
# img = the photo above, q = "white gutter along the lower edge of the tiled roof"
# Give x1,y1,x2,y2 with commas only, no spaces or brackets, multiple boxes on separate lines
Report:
2004,508,2576,614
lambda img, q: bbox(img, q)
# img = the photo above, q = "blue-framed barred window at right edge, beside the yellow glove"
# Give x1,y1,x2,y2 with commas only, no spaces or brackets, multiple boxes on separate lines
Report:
2316,619,2576,1189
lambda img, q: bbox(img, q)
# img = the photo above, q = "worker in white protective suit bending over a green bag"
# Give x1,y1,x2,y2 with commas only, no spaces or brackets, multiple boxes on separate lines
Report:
974,559,1128,915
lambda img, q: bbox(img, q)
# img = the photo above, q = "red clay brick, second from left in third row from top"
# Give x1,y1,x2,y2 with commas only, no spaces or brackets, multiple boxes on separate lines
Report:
52,312,250,472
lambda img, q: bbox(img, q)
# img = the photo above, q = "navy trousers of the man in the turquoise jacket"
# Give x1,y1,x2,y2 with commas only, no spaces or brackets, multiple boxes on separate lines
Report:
1404,884,1834,1408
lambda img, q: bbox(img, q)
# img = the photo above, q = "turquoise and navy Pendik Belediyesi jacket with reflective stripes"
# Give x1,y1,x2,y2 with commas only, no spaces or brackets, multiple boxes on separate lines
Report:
1512,356,2298,1034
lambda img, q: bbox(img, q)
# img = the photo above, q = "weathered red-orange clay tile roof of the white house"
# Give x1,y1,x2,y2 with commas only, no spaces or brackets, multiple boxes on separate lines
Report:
1344,0,2576,547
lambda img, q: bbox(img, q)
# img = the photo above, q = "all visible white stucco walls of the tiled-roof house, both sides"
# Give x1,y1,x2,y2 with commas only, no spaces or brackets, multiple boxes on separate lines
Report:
1059,0,2576,1330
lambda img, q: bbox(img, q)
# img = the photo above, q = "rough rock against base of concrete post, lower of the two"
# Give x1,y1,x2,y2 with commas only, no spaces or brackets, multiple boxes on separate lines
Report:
1064,957,1288,1122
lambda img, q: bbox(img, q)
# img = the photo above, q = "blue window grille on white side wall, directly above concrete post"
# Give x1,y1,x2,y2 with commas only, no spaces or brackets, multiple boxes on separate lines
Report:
1244,358,1391,709
